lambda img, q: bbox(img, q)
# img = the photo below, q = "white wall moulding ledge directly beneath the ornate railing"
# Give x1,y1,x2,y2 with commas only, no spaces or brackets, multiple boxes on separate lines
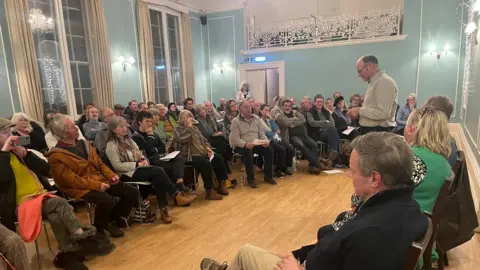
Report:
241,35,408,55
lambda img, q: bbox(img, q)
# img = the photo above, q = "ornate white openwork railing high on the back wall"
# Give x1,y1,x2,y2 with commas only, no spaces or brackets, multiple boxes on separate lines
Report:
247,7,403,50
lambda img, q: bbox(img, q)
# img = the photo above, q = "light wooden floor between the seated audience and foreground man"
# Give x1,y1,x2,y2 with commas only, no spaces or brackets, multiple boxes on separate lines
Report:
28,161,480,270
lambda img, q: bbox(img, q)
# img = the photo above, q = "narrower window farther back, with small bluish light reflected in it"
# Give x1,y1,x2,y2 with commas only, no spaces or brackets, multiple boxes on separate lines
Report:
150,8,185,105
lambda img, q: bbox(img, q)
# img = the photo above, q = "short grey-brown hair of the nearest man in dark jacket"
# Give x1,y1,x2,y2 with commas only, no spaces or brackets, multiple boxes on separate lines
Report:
350,132,413,188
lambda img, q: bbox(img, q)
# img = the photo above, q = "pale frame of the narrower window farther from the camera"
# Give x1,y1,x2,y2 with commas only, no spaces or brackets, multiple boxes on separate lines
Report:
147,5,188,106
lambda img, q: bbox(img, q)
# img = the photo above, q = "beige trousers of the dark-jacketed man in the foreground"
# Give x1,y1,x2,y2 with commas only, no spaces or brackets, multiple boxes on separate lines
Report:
227,244,281,270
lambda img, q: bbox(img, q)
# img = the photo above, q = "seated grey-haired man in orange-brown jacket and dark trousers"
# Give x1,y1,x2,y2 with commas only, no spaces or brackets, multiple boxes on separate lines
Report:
48,114,140,237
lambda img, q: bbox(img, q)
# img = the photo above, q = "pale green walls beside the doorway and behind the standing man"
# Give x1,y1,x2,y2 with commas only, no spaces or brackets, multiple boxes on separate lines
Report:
192,0,463,121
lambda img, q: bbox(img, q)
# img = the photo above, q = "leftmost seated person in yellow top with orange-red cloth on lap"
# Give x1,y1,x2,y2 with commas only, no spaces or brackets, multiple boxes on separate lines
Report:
0,118,115,269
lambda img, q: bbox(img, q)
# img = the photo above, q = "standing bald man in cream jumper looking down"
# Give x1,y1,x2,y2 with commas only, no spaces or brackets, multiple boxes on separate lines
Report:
348,55,398,134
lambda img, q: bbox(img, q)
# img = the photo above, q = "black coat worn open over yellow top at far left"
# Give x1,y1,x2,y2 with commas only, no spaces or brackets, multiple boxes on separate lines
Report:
0,151,53,231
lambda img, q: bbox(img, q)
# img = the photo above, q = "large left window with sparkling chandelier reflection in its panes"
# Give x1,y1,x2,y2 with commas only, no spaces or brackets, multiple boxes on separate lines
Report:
28,0,94,116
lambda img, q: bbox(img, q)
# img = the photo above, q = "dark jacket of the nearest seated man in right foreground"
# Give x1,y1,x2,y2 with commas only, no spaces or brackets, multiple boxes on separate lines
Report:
306,186,428,270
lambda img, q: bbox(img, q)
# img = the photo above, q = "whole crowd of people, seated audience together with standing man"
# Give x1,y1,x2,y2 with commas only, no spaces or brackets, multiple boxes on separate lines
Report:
0,56,464,270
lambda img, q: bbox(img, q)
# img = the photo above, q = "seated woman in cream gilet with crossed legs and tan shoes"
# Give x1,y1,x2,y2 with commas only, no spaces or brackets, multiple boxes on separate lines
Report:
106,116,196,223
